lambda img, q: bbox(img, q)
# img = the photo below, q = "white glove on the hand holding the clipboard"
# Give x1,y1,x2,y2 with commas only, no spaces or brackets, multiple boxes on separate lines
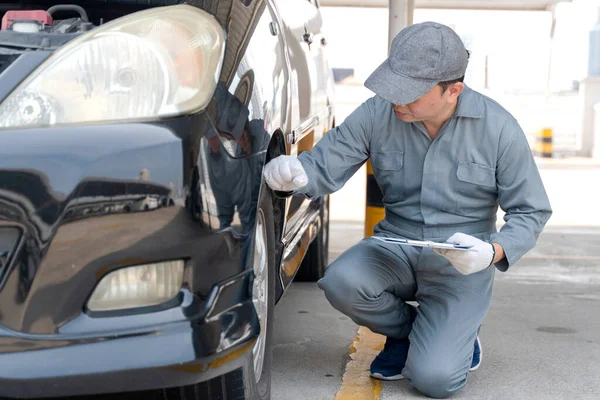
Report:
433,233,495,275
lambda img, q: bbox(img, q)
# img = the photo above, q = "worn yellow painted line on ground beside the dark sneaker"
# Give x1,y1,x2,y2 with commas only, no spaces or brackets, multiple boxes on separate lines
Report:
335,326,385,400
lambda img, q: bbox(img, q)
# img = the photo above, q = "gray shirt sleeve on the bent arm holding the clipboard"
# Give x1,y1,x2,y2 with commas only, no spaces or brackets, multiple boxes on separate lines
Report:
490,123,552,271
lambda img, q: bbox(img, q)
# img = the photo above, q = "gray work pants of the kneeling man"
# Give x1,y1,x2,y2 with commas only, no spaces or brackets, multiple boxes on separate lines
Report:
318,217,495,398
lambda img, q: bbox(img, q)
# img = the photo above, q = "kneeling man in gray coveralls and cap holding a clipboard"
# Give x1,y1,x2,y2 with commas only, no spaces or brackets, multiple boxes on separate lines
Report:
264,22,552,398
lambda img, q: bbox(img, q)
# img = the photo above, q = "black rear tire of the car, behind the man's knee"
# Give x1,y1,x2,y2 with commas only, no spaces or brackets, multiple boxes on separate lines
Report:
295,196,329,282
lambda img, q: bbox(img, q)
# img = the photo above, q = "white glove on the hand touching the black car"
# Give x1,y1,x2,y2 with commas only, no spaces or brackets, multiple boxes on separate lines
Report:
263,156,308,192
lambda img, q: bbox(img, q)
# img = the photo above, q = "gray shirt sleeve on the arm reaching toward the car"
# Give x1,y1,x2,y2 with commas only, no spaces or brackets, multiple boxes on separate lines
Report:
293,98,374,199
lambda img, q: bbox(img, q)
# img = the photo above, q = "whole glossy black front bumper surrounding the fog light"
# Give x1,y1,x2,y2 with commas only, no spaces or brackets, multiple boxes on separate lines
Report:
0,113,261,398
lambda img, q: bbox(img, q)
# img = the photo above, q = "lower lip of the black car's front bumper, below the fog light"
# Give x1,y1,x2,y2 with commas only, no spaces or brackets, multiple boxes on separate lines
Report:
0,274,259,398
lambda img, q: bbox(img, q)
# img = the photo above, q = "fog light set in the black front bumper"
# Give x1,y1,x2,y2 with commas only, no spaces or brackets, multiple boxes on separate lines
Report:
87,260,183,311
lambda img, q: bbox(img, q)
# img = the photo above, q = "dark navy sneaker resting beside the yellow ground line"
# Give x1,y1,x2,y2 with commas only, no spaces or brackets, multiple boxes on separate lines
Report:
371,337,410,381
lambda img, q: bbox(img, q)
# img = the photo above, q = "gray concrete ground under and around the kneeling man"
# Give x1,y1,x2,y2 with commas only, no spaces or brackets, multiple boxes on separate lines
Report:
272,221,600,400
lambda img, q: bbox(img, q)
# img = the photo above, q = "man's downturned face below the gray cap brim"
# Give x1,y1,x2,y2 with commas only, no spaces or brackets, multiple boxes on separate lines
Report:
393,85,451,122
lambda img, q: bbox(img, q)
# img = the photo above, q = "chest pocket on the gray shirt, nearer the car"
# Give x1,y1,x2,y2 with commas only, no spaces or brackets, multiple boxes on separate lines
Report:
371,150,406,204
